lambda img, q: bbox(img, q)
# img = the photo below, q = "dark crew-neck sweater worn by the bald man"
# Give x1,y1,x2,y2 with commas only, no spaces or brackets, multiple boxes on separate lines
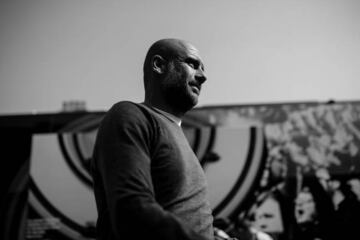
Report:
92,102,214,240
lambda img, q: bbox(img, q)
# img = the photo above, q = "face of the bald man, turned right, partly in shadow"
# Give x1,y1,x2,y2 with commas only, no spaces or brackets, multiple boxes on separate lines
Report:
161,46,206,112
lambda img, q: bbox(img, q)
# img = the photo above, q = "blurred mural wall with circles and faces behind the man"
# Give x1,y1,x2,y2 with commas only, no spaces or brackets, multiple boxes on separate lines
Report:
0,102,360,240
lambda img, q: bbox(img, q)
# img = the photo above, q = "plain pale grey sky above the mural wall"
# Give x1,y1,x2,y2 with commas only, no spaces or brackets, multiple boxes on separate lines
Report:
0,0,360,114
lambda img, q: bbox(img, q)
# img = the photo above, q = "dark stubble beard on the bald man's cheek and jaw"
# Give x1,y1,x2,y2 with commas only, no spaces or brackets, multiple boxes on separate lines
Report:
162,63,198,113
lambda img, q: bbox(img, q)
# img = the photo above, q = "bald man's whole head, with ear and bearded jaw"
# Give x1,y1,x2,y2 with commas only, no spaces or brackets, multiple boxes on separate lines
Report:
144,39,206,117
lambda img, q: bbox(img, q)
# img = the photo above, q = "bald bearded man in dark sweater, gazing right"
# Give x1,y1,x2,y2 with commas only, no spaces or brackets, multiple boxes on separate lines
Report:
92,39,214,240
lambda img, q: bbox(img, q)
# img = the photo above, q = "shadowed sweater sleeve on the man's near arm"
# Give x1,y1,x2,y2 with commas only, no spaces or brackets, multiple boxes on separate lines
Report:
94,104,211,240
